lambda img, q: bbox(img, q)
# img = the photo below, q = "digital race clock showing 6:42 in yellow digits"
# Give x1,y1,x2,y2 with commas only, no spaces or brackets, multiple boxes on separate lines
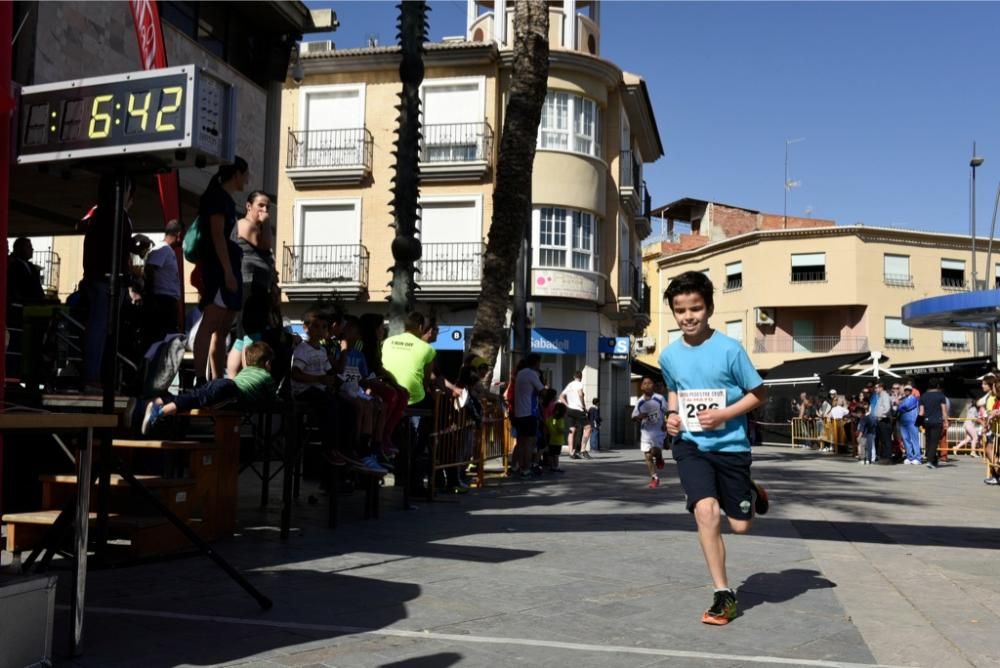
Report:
17,65,235,167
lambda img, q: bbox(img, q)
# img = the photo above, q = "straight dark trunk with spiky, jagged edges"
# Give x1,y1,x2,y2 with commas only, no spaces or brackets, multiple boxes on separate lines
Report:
389,0,427,335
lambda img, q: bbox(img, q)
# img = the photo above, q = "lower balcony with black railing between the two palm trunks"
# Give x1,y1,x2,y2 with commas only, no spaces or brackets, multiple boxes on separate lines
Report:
417,241,486,301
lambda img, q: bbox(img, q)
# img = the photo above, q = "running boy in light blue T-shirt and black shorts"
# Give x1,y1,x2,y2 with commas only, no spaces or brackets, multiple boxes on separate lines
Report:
660,271,768,625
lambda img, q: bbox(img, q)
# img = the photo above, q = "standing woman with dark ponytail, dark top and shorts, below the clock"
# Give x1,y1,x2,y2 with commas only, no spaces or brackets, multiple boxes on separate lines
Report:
194,156,249,380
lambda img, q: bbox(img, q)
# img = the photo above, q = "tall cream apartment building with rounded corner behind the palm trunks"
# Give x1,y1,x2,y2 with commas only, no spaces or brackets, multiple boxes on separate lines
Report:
277,0,663,448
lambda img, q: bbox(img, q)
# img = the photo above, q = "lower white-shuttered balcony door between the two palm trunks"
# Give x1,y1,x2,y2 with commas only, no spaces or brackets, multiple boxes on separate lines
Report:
419,197,483,283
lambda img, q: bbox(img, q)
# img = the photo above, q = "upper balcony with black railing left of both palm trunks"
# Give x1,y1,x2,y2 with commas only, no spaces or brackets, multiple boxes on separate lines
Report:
285,128,373,187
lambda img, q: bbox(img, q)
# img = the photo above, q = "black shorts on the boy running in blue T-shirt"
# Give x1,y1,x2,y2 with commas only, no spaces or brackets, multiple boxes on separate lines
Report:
673,441,753,520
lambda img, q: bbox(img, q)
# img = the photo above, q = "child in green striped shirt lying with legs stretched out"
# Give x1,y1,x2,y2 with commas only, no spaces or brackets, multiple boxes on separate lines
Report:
142,342,275,434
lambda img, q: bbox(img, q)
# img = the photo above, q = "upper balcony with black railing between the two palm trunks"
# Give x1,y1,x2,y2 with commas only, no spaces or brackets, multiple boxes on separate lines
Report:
420,123,493,181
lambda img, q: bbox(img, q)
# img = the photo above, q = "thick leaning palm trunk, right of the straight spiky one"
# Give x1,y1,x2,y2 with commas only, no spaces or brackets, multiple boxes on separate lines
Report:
471,0,549,365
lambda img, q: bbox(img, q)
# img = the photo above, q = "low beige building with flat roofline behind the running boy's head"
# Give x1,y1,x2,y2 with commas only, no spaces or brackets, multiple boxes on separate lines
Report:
641,201,988,369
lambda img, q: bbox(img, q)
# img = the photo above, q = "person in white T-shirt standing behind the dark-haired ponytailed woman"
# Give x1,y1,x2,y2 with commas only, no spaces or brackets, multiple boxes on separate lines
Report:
142,220,184,348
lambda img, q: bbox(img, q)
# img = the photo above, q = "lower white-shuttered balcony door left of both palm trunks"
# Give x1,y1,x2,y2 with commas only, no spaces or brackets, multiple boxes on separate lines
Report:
293,200,362,283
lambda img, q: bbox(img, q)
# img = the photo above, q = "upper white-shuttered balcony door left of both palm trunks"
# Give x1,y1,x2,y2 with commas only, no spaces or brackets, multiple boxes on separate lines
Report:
299,86,365,167
